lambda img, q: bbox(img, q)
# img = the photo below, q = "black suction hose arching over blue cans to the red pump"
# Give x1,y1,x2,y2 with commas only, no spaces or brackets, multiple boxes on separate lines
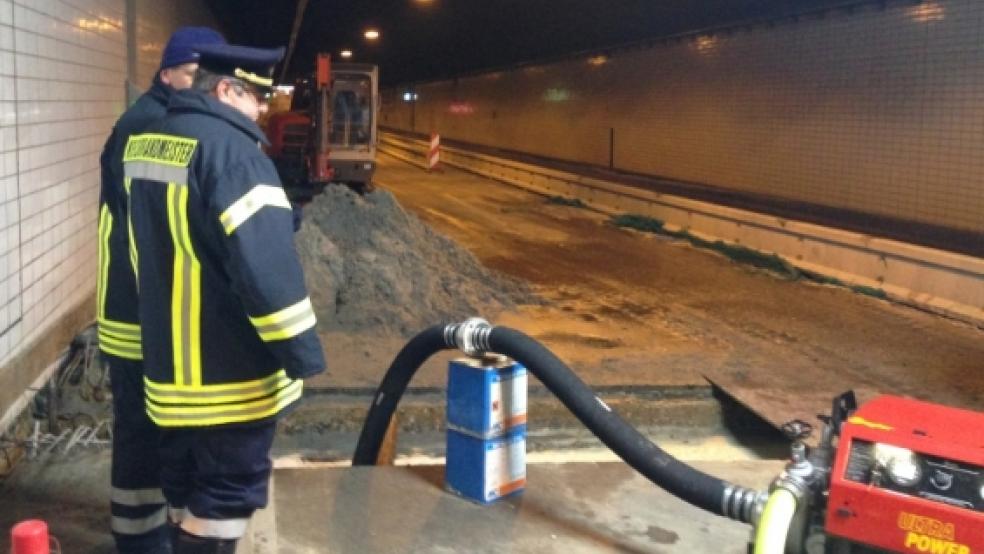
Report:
352,322,758,523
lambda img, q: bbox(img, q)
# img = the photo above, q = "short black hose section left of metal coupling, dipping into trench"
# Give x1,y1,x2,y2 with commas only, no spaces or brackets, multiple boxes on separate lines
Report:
352,325,452,465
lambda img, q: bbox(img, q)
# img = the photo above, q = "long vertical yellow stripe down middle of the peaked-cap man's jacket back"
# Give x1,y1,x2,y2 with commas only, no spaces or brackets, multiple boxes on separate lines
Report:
167,183,202,385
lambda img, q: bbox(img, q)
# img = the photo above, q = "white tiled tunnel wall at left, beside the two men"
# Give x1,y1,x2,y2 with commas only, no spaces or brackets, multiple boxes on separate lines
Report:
0,0,217,422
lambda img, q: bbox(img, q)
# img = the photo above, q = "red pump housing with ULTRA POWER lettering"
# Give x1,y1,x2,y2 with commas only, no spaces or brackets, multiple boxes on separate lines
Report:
826,396,984,554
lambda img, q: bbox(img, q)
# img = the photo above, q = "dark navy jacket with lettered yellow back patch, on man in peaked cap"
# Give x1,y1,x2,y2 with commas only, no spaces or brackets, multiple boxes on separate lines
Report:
123,90,325,427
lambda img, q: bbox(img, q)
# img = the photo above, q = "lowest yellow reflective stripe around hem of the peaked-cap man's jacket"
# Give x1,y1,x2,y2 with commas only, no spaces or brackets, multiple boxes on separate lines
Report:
147,379,304,427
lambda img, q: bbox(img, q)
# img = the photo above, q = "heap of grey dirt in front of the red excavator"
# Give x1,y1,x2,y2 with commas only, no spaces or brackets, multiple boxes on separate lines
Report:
296,186,537,336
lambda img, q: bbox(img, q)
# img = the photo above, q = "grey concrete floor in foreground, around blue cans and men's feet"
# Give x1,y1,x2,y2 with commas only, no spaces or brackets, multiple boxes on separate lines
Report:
0,444,782,554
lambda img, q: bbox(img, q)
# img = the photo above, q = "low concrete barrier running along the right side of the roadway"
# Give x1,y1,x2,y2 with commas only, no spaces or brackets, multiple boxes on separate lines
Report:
379,133,984,326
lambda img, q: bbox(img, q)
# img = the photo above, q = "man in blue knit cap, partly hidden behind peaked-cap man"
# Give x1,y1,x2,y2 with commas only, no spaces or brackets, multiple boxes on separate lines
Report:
96,27,225,554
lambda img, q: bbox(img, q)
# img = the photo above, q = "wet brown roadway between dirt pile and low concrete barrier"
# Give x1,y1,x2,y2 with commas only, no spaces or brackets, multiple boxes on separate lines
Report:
368,156,984,425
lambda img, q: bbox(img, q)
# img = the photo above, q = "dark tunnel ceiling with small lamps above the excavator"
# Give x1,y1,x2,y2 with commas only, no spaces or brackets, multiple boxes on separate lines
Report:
206,0,863,85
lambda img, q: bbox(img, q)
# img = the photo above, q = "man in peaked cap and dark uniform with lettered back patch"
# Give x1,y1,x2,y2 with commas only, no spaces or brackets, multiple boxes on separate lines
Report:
123,45,325,554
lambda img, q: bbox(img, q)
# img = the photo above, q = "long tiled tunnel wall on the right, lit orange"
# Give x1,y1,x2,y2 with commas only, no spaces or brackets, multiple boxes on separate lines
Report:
381,0,984,239
